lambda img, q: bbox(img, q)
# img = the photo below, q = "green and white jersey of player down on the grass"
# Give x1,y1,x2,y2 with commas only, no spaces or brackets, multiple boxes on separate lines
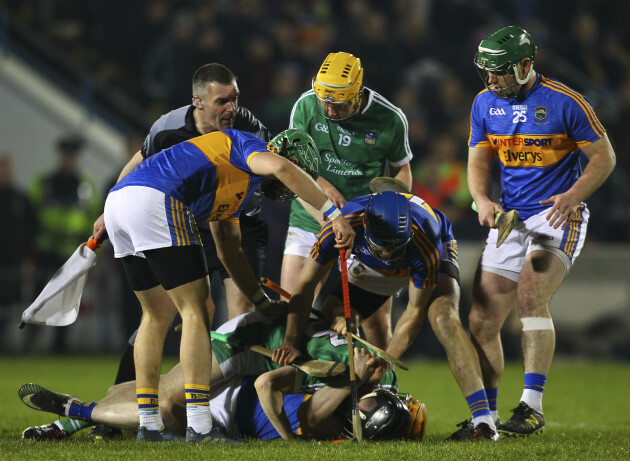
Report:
211,312,398,394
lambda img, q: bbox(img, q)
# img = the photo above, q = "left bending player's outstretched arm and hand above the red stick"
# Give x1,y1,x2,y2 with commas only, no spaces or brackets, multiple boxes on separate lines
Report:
249,152,355,250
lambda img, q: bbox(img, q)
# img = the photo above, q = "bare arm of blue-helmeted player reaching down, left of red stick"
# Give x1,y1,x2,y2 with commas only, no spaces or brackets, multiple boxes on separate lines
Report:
272,258,332,365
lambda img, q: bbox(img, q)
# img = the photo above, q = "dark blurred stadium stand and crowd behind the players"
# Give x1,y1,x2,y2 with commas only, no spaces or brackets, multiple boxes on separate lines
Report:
0,0,630,360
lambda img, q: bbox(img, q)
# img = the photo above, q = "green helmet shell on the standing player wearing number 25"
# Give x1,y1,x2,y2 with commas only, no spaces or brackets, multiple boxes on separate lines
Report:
475,26,537,94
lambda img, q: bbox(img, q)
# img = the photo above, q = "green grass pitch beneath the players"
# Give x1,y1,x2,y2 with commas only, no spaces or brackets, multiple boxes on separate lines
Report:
0,357,630,461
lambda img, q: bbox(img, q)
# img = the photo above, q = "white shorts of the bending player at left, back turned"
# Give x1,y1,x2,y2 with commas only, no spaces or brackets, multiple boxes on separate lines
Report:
105,186,201,258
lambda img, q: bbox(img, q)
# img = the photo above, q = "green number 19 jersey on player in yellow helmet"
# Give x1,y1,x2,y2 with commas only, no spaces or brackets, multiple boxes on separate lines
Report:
289,88,412,233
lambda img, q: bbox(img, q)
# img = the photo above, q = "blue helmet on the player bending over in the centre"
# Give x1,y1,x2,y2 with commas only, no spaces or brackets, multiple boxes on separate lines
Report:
364,191,412,261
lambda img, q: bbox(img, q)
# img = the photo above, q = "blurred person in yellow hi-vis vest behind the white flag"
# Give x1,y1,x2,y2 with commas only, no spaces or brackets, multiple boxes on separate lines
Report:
29,136,103,352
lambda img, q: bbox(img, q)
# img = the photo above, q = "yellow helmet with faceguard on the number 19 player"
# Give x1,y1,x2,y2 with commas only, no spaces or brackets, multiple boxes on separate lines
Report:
313,52,363,122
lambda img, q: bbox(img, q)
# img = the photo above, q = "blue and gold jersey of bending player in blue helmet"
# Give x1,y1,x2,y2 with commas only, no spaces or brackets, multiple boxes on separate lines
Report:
310,194,444,289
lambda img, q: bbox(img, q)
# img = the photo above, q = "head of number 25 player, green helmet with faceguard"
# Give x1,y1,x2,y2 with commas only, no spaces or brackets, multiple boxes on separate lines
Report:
474,26,537,98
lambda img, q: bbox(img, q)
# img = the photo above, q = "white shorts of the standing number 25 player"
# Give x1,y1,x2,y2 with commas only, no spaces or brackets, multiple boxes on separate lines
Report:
479,204,589,282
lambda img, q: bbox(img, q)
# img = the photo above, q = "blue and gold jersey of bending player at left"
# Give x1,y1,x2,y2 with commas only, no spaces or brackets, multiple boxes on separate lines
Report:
112,130,275,222
